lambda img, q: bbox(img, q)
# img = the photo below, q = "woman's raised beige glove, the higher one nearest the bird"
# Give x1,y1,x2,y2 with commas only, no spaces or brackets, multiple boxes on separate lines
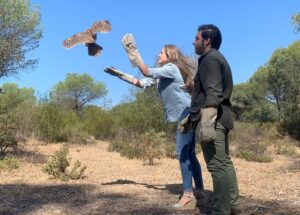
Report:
122,34,144,67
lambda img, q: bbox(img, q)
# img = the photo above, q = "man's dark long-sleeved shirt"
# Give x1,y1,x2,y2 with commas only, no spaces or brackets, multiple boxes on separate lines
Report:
190,49,233,129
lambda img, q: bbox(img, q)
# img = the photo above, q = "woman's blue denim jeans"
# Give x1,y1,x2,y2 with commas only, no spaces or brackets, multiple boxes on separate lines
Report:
176,108,203,192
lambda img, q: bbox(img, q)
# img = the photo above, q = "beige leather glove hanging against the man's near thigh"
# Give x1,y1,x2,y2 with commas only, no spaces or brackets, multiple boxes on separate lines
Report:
198,107,218,143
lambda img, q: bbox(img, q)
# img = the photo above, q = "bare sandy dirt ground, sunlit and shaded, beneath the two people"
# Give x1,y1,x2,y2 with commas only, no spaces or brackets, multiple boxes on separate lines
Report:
0,141,300,215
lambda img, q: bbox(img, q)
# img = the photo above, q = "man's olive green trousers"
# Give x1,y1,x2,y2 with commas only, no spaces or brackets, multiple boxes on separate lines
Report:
201,123,239,215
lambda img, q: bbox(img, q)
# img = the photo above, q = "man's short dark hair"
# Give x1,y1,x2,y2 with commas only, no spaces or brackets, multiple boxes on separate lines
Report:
198,24,222,50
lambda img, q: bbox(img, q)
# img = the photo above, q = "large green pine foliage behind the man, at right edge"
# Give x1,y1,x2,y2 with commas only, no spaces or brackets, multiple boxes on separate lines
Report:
232,41,300,140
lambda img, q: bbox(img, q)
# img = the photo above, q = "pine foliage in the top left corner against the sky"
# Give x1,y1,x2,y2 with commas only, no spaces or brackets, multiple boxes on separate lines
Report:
0,0,42,77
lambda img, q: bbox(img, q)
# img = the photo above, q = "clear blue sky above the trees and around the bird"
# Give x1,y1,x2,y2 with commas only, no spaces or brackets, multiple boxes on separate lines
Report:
0,0,300,105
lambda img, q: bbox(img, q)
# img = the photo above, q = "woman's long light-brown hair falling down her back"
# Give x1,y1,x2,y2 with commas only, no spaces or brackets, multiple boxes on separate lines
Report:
164,45,196,94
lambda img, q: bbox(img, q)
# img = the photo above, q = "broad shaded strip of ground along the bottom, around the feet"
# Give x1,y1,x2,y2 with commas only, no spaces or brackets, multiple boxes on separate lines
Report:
0,180,300,215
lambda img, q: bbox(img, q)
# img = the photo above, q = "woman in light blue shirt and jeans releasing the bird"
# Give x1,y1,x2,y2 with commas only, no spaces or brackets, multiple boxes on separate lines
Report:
105,35,203,209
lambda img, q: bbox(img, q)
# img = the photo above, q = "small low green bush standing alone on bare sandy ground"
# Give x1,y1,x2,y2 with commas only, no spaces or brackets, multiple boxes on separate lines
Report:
43,146,86,181
